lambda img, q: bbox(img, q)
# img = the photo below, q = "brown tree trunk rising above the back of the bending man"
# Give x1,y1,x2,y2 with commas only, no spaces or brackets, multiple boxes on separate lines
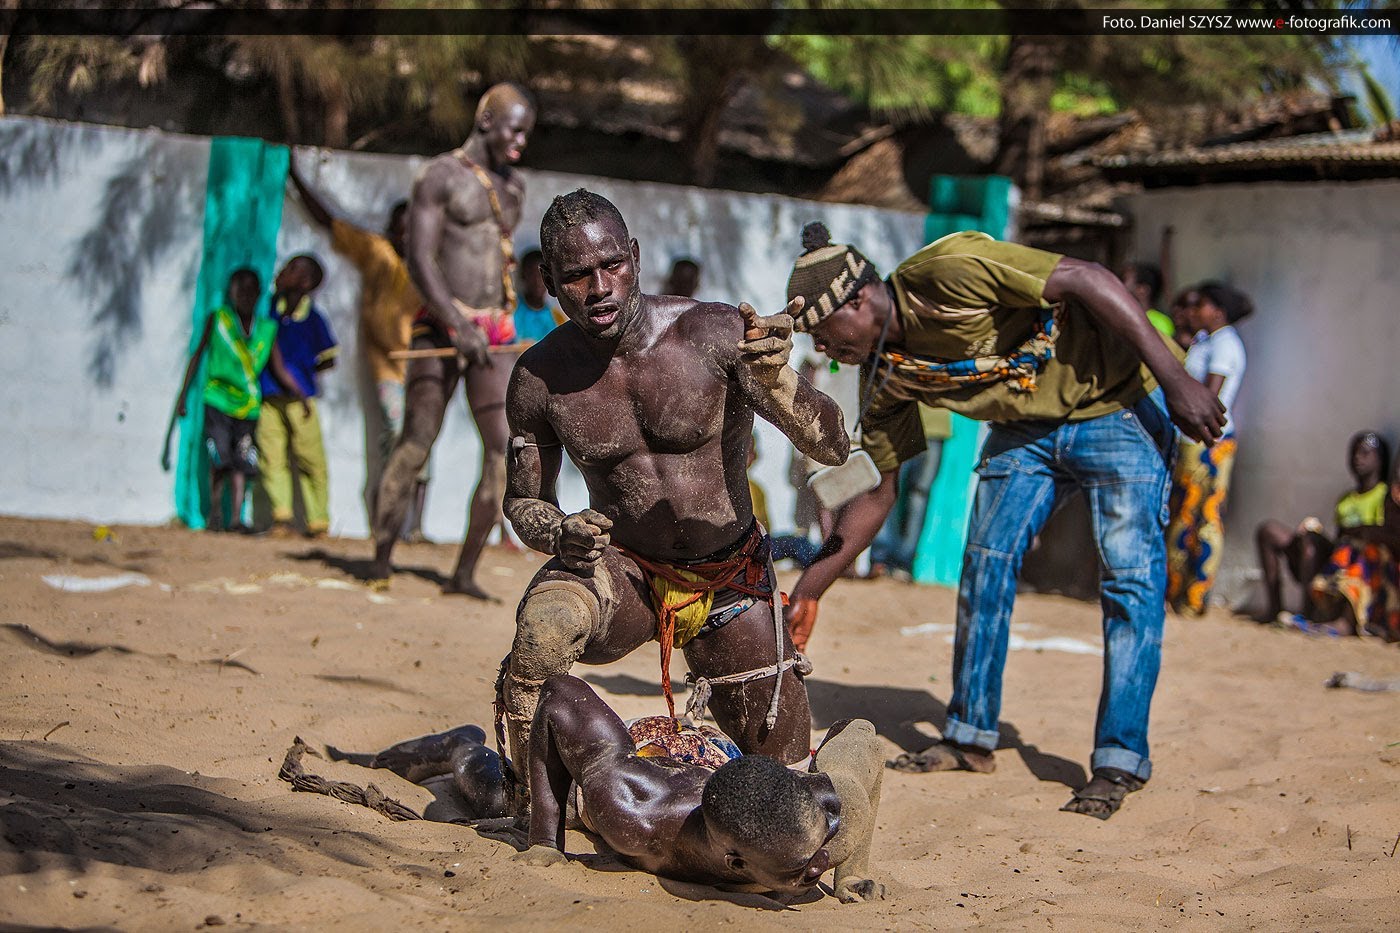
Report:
993,35,1065,200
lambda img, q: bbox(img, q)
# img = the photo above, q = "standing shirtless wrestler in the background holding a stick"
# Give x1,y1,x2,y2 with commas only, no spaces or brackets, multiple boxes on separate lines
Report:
371,84,535,600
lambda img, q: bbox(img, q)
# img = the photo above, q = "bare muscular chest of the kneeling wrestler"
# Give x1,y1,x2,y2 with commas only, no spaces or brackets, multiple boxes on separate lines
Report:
552,349,731,467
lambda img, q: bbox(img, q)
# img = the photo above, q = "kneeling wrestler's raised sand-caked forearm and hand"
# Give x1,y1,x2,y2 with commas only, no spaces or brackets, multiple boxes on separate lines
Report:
735,297,851,467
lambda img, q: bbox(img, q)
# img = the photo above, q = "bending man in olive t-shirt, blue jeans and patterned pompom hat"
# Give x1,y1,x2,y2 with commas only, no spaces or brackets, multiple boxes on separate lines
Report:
788,224,1224,820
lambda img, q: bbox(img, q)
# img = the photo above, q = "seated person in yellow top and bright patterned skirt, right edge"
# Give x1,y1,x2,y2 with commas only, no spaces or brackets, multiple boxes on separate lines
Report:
1301,464,1400,642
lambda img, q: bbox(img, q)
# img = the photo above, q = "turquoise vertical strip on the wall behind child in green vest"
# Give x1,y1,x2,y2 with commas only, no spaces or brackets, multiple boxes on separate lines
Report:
175,136,290,528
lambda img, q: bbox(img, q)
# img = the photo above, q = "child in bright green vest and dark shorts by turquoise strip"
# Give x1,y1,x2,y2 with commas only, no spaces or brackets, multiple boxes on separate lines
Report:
167,269,277,531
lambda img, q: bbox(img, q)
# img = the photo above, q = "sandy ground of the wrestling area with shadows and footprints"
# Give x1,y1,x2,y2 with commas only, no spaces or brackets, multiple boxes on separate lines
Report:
0,518,1400,930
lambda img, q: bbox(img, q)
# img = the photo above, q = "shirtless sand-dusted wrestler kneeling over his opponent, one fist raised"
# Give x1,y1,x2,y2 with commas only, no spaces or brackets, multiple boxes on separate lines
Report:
501,189,850,778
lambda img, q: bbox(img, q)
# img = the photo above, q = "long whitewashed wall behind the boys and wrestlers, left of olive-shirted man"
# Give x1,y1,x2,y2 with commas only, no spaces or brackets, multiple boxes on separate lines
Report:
0,118,923,539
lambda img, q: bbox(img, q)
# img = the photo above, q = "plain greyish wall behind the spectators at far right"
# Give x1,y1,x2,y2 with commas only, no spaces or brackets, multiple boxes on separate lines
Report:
1124,181,1400,601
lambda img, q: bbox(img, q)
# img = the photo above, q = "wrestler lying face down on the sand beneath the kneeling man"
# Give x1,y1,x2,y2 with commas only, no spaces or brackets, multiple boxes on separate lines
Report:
371,675,885,904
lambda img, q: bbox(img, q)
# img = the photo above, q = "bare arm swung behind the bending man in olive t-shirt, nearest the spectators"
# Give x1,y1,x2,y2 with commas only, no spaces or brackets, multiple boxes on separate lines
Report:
1044,258,1225,445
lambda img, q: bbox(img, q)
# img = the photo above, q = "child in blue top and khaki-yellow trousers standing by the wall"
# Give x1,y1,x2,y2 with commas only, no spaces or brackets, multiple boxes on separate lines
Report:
258,255,339,538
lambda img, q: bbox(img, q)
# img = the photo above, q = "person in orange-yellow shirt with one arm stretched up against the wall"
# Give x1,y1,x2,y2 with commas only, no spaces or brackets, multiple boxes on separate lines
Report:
290,158,431,541
